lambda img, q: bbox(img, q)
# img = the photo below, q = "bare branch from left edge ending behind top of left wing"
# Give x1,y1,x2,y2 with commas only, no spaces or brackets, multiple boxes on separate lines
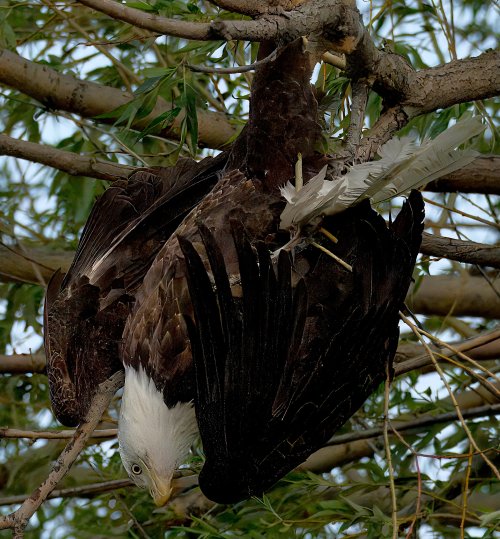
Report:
0,133,135,181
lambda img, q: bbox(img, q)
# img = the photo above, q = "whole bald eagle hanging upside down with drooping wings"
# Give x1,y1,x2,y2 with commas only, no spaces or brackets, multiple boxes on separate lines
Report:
46,40,482,505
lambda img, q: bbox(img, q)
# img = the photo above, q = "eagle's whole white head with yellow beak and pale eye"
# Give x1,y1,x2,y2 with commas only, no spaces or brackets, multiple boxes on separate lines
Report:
118,367,198,506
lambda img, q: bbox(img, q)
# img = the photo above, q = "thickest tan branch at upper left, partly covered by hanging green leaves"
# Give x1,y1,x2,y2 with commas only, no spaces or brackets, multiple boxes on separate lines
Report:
0,48,236,148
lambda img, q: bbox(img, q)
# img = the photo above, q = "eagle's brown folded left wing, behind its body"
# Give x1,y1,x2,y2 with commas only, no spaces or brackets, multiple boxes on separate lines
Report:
44,154,226,425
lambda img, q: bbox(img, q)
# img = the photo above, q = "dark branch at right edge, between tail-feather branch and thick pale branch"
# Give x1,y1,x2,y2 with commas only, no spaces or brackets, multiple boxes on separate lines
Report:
420,232,500,269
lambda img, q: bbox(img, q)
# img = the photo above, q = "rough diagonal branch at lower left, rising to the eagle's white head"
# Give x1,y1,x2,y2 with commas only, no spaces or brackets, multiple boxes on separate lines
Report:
0,371,124,539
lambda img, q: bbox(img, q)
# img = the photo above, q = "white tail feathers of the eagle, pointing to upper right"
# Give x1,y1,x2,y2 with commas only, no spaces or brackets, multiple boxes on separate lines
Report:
280,116,485,229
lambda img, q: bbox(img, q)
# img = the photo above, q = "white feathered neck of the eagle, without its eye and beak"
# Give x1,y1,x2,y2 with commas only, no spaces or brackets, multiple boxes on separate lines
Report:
118,367,198,470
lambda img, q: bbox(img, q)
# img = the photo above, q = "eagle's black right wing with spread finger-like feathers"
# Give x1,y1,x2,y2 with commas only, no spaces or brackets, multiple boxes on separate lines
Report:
180,193,423,503
